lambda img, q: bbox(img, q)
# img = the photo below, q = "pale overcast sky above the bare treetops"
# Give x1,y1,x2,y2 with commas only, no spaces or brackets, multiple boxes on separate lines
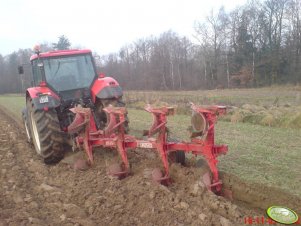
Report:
0,0,246,55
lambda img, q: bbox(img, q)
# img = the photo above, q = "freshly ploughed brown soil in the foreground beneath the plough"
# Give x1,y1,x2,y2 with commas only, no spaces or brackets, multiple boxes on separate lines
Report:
0,107,301,226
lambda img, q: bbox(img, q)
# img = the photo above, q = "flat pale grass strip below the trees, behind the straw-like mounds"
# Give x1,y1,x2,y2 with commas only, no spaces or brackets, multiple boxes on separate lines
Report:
125,86,301,106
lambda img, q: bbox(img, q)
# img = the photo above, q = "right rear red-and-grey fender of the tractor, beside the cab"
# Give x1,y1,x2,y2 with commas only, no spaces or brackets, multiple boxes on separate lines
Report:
91,77,123,103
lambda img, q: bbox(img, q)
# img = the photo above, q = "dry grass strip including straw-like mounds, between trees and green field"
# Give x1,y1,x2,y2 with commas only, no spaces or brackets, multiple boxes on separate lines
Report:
124,86,301,129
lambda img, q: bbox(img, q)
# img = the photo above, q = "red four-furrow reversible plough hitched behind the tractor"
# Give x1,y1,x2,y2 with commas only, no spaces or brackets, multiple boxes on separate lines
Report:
68,103,228,194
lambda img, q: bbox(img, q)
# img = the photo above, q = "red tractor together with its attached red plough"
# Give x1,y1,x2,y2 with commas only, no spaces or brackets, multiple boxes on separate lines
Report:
19,47,228,194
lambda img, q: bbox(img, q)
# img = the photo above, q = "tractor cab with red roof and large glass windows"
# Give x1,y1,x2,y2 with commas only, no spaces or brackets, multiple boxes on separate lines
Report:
30,50,97,100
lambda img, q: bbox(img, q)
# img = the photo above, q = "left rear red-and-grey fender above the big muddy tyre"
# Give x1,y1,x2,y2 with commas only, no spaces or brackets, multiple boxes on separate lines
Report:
26,87,61,111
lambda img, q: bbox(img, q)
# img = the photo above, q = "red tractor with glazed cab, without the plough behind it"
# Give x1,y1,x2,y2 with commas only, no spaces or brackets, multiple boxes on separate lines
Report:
19,49,128,164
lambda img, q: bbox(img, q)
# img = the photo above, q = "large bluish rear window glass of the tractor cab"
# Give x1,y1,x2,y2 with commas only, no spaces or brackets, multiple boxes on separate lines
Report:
43,55,95,91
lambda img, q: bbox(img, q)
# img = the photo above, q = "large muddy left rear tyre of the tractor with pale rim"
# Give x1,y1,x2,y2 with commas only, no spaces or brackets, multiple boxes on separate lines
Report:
27,101,64,164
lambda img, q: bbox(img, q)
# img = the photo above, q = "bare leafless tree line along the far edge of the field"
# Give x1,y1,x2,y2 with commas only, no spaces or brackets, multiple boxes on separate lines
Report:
0,0,301,92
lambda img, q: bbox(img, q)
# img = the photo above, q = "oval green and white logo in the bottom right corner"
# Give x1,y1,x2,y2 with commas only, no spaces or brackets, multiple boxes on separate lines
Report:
267,206,298,224
